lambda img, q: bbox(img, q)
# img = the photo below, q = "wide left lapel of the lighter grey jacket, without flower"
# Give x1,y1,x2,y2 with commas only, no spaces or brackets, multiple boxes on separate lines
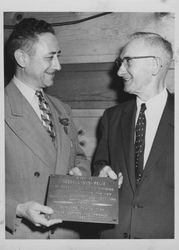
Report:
6,83,56,170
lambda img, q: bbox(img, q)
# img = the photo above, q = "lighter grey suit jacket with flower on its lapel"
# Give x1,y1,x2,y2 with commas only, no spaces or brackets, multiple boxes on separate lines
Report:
5,81,90,238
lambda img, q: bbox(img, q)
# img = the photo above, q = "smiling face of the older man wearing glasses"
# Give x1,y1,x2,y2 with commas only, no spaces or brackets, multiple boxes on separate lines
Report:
117,40,155,96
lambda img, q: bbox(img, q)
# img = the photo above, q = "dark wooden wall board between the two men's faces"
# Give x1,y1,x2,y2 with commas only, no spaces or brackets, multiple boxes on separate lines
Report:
47,63,174,109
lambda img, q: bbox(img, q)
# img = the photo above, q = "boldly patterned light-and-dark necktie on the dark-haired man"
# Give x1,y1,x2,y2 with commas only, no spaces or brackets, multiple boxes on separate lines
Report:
35,90,55,142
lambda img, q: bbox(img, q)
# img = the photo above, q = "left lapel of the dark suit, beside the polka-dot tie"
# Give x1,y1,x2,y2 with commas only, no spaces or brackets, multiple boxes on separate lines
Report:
121,101,136,191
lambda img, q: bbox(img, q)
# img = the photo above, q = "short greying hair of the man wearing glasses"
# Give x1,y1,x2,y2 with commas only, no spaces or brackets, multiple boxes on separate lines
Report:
130,32,173,60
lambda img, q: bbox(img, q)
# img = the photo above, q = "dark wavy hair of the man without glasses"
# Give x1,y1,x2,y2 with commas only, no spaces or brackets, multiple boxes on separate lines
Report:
7,18,55,60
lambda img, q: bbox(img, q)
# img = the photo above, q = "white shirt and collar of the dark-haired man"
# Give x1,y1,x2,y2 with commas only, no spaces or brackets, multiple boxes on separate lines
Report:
13,76,43,120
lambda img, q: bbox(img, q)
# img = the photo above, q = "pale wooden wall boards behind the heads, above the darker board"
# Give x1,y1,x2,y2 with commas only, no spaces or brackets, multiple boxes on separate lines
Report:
4,12,174,64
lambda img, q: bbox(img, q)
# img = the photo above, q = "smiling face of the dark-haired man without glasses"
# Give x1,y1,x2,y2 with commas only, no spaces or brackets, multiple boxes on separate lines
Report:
24,33,61,88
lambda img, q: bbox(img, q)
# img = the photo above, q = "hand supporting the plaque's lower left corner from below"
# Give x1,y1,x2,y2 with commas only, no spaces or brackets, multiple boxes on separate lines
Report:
16,201,62,227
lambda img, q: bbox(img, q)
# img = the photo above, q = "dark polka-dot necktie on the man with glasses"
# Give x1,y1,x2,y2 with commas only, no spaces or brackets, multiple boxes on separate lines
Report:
135,103,146,185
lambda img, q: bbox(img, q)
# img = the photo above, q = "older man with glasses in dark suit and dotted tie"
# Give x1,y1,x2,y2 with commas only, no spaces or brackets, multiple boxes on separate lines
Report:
94,32,174,239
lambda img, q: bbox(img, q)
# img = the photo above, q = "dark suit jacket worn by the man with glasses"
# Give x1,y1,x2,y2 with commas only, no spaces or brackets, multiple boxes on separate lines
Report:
94,94,174,239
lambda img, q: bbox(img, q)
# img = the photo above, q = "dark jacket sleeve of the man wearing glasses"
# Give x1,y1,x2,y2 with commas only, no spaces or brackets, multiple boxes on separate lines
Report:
92,111,110,176
